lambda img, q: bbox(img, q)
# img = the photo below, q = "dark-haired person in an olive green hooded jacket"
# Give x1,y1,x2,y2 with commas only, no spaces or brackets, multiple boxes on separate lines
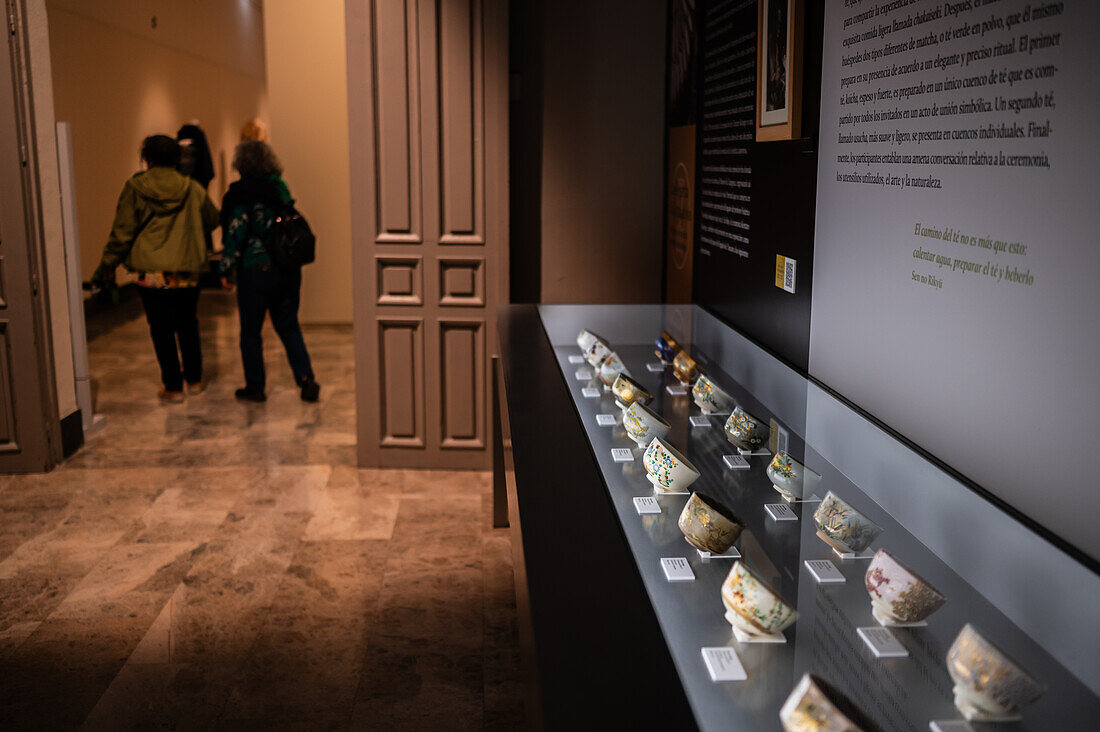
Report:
92,134,218,402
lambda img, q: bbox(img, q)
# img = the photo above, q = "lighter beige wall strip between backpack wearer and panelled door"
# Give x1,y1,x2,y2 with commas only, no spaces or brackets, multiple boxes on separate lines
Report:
264,0,352,323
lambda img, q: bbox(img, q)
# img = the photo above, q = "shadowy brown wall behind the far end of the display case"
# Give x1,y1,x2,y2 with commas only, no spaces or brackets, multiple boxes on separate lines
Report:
541,0,668,303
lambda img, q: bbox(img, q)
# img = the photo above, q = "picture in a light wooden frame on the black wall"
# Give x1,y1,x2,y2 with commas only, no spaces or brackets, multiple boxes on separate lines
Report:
756,0,803,142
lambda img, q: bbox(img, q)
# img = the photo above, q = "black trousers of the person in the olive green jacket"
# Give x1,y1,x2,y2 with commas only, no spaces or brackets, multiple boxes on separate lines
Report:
138,287,202,392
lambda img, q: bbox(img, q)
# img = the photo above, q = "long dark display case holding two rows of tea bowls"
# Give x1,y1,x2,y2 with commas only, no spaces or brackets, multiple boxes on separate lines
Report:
498,305,1100,732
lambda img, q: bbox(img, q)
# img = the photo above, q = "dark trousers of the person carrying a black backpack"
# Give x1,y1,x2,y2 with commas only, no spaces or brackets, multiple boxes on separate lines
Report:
237,264,314,392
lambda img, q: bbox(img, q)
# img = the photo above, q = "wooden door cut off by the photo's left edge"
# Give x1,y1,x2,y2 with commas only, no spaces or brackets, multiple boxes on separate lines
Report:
0,0,61,473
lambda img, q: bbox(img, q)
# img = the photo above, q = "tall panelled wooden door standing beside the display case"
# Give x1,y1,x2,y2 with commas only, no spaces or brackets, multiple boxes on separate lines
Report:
345,0,508,469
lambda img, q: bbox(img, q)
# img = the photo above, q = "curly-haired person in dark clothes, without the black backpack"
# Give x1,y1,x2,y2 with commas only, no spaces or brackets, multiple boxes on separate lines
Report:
218,140,321,402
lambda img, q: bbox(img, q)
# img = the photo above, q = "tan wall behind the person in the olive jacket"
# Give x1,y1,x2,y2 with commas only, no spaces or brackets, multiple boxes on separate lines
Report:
46,0,266,280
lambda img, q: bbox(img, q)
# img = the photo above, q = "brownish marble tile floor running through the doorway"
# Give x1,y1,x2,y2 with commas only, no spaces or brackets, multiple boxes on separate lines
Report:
0,293,523,730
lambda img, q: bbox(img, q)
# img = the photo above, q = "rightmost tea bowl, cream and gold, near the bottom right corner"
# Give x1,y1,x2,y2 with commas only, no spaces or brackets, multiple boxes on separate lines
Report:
947,623,1046,720
